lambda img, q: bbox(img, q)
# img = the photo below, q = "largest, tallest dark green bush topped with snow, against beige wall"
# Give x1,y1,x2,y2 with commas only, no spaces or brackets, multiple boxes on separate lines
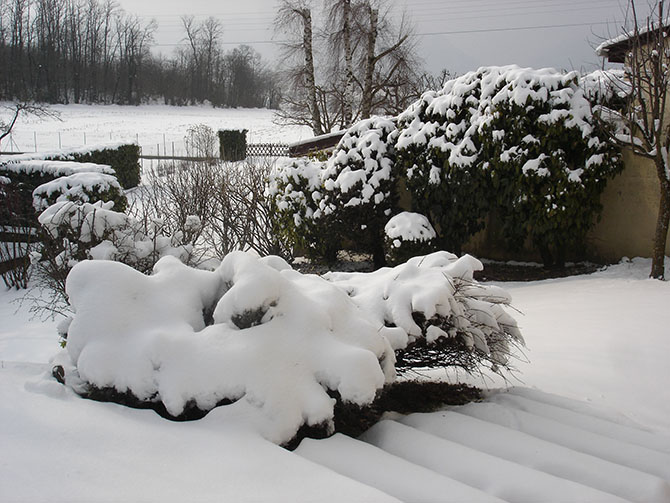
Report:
397,66,620,263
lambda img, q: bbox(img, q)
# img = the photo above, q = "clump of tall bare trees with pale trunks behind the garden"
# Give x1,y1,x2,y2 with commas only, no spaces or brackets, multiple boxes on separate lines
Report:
275,0,419,135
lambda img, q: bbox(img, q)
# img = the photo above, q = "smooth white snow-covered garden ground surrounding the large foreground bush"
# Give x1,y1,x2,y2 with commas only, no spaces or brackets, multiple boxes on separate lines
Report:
0,259,670,502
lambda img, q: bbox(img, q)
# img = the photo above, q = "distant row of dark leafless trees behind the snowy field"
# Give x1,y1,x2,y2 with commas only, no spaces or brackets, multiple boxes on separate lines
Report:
0,0,281,108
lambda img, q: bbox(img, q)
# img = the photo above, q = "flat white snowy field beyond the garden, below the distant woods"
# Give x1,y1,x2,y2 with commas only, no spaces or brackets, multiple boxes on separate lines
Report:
0,103,313,155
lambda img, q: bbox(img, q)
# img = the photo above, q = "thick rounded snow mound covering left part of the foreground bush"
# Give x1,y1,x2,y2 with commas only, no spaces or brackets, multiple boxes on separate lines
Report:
59,252,395,443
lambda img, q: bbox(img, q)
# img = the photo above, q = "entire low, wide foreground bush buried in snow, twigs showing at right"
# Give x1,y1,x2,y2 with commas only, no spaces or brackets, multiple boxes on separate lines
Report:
56,252,522,443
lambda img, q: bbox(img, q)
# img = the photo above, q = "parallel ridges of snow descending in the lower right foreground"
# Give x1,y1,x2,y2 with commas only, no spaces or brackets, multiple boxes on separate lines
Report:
296,388,670,503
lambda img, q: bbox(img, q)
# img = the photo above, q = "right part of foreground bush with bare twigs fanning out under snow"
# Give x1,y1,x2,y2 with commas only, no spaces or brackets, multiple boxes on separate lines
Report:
325,252,524,373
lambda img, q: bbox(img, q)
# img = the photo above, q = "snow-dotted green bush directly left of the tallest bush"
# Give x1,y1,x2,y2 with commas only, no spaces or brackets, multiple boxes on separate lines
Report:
270,117,397,266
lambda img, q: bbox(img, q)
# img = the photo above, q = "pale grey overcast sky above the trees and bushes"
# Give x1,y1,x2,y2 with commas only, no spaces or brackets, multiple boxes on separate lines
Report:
118,0,647,73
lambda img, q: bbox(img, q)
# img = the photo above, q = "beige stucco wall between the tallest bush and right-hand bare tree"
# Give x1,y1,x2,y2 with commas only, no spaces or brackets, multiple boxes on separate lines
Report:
588,150,670,262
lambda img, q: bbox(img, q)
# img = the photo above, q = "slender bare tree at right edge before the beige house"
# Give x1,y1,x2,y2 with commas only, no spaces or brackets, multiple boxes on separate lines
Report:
608,0,670,279
